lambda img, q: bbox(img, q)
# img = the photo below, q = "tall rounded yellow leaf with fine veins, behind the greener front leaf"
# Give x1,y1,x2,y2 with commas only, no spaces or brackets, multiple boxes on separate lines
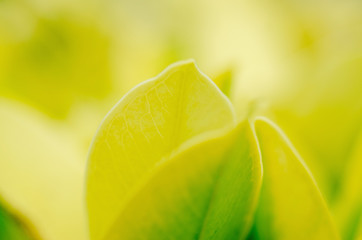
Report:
87,61,235,240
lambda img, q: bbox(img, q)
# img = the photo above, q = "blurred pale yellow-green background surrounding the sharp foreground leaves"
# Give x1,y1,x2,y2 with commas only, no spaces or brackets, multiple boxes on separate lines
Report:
0,0,362,240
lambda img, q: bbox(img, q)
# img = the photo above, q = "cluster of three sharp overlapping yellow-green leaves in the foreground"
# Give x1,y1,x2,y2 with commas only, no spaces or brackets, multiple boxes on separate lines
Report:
87,62,339,240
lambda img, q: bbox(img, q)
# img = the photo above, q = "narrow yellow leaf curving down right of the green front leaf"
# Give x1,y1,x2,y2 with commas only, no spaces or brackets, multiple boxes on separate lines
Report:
255,118,338,239
